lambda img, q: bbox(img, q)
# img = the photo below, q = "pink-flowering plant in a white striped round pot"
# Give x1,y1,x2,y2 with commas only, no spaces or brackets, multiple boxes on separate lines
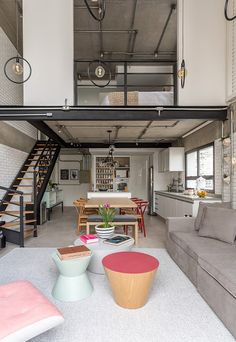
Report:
95,203,116,239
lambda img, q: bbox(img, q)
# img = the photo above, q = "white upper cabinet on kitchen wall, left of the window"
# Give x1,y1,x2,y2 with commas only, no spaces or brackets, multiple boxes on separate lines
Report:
158,147,184,172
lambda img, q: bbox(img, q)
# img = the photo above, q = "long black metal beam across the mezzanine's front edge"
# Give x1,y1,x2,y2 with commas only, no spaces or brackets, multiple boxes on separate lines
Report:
0,106,227,121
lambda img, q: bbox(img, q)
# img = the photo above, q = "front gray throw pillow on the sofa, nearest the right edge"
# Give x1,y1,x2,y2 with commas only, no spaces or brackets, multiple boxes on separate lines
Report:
199,207,236,244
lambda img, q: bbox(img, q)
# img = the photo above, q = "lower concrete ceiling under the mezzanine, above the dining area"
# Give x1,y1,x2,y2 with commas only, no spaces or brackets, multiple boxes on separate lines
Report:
47,120,204,143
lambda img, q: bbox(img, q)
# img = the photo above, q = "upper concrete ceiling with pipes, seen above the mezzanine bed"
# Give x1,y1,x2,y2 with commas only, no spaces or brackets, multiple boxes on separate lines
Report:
74,0,177,60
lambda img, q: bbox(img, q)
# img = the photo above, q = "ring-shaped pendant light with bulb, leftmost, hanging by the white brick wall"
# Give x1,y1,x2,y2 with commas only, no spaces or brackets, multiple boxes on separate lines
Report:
4,0,32,84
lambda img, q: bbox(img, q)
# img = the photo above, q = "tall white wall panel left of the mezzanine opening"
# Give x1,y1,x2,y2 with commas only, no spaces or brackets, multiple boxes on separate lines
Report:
23,0,74,105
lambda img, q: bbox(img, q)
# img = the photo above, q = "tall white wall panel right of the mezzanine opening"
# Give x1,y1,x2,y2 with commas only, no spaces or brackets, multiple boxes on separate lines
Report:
177,0,226,105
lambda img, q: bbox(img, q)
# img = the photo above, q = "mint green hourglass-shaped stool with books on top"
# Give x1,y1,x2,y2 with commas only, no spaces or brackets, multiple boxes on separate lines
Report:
52,253,93,302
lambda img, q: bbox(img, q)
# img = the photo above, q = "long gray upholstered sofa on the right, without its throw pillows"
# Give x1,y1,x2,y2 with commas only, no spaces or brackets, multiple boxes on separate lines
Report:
166,217,236,338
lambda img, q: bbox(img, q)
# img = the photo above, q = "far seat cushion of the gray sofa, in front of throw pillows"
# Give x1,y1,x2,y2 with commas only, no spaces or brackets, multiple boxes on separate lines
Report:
169,231,236,261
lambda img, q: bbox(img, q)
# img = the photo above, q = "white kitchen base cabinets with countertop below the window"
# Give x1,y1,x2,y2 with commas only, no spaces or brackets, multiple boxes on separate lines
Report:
155,191,222,219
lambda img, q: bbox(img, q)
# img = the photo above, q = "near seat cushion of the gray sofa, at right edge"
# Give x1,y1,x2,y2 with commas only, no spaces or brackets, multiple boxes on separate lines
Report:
198,252,236,298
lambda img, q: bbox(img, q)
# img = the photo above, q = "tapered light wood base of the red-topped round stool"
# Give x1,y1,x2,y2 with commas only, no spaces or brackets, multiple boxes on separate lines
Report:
104,267,157,309
